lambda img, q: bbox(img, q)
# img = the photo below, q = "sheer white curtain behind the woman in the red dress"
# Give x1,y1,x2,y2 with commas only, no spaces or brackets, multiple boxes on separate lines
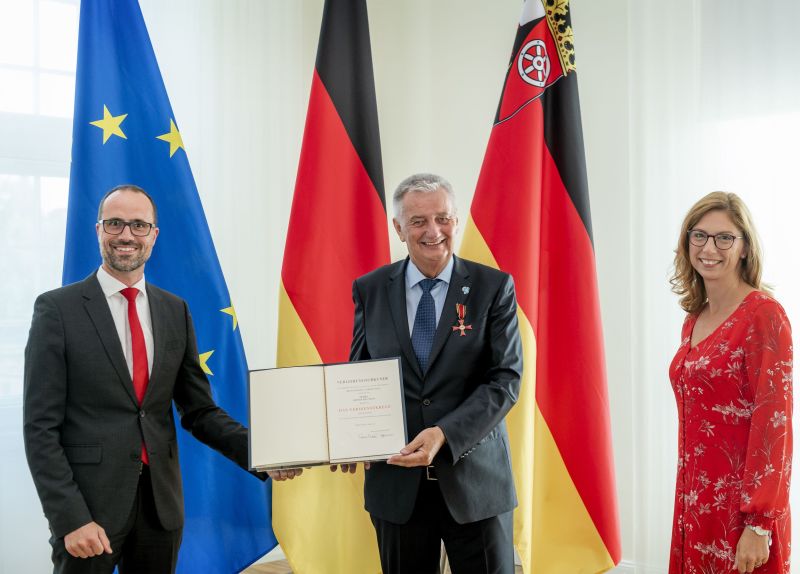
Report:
608,0,800,572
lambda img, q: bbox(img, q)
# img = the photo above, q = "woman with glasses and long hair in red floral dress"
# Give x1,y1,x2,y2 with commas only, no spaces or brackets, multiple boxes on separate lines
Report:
669,192,792,574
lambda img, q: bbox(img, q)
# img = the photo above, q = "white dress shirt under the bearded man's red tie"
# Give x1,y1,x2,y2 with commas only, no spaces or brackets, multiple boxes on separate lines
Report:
97,267,153,379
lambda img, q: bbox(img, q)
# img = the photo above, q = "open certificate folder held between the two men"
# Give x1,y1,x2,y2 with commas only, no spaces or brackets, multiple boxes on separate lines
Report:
249,358,408,470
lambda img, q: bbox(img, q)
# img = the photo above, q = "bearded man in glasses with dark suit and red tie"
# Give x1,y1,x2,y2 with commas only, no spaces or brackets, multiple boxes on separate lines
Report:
23,185,300,574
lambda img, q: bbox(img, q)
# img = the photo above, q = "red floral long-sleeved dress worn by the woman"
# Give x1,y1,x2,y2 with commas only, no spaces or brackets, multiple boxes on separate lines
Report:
669,291,792,574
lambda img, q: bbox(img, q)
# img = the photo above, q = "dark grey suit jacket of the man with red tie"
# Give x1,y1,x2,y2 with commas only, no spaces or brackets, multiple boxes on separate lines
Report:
23,274,253,538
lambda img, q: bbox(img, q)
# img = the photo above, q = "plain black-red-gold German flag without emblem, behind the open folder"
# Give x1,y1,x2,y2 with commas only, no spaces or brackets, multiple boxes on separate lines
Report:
272,0,389,574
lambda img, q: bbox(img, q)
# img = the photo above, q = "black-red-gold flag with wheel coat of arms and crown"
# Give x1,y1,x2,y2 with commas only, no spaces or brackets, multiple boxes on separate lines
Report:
461,0,621,574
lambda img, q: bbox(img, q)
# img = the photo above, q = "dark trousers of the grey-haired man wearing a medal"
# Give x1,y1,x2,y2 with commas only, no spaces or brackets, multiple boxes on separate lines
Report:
372,478,514,574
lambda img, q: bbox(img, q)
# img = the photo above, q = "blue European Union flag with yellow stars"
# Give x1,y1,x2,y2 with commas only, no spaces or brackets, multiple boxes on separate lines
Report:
63,0,277,573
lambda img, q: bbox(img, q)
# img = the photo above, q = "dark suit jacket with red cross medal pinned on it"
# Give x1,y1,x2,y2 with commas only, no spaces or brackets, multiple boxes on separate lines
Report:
350,258,522,524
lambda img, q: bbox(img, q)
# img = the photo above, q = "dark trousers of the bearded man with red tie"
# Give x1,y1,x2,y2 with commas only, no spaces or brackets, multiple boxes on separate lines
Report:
50,465,183,574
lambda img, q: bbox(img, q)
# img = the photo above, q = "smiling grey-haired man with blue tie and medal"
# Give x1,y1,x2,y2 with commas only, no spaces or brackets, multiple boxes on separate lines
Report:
350,174,522,574
